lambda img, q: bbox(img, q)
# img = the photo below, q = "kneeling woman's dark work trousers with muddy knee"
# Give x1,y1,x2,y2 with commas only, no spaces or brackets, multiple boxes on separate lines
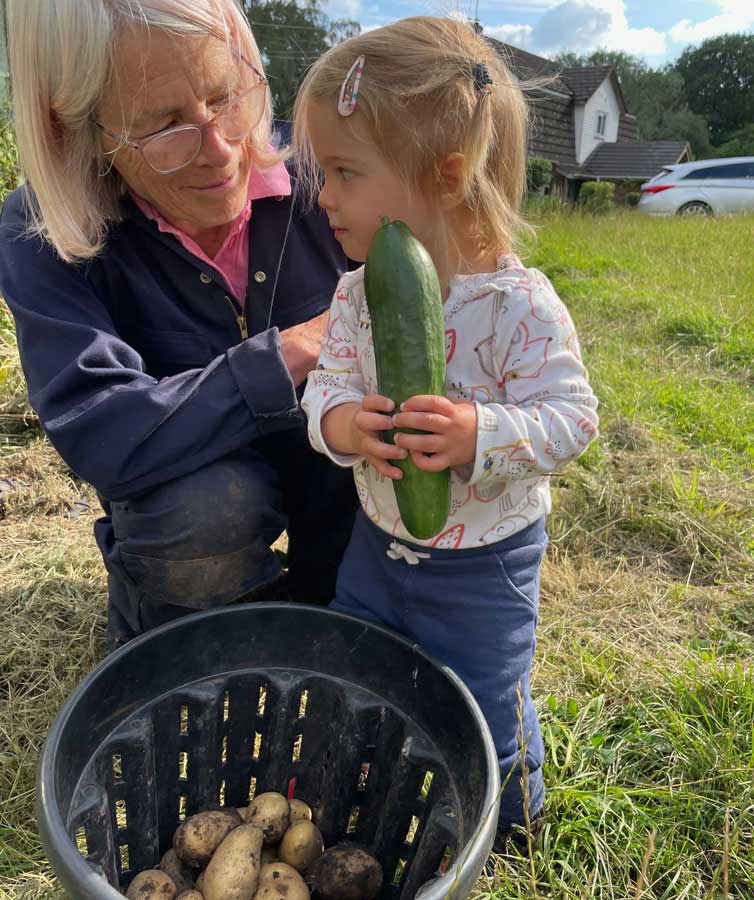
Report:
95,428,357,649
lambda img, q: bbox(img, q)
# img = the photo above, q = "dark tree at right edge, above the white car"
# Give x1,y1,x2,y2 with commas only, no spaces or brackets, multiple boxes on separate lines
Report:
674,34,754,145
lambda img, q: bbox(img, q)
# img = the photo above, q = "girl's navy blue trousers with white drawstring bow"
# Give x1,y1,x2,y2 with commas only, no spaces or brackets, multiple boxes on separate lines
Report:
330,511,547,831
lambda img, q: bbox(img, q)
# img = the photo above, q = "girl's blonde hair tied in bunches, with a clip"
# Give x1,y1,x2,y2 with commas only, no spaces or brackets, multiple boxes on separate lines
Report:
293,16,529,250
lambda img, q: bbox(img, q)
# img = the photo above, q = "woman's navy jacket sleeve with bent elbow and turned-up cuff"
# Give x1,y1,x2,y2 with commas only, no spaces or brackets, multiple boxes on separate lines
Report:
0,192,301,500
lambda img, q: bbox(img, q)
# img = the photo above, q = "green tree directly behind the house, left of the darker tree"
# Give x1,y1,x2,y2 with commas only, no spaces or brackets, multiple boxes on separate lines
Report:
556,50,711,157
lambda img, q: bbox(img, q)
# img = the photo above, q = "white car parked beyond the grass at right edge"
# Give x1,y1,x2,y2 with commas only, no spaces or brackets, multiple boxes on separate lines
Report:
638,156,754,216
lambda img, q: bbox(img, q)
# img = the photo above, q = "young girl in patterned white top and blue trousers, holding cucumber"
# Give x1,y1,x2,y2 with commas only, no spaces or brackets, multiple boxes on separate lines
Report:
294,17,597,852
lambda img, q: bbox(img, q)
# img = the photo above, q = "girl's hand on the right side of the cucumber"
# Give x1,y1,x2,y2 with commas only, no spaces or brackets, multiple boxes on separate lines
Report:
392,394,477,472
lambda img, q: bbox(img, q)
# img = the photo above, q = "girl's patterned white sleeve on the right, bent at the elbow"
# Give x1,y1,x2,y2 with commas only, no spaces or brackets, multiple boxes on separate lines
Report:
469,270,598,484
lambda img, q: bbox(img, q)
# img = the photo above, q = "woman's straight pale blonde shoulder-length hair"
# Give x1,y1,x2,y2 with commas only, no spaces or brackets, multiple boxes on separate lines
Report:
7,0,284,262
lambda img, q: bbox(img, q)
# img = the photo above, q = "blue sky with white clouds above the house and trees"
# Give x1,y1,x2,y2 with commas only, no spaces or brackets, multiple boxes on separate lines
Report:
323,0,754,66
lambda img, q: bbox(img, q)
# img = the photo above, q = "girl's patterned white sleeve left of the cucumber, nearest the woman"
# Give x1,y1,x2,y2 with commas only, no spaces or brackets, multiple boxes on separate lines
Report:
301,269,366,468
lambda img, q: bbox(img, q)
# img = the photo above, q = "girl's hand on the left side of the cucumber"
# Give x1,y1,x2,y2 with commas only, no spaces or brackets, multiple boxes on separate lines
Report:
322,394,408,481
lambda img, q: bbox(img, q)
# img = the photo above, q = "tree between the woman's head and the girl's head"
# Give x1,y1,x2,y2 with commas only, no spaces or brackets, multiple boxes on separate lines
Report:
242,0,361,117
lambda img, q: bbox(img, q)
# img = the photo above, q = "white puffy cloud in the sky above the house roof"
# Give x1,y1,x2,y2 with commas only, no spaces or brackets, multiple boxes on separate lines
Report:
485,0,664,57
